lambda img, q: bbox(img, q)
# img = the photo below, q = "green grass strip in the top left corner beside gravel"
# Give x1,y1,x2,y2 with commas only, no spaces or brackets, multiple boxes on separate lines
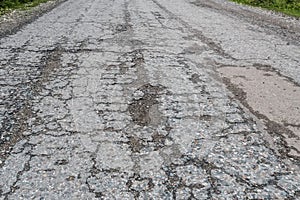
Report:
0,0,48,15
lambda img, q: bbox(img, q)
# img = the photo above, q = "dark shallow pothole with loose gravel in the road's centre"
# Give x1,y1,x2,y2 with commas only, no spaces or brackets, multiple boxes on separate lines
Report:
128,84,165,126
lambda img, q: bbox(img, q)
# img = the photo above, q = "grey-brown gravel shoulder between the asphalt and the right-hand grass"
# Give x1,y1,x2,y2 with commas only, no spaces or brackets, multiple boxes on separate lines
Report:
192,0,300,45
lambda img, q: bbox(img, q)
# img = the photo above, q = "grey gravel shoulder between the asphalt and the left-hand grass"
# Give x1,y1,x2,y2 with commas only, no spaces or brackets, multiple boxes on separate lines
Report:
0,0,67,38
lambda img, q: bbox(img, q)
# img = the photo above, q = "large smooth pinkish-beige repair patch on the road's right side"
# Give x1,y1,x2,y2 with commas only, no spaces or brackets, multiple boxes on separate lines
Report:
218,65,300,157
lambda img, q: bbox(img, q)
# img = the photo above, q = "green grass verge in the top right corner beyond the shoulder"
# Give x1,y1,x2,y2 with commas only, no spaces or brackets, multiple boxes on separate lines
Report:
232,0,300,17
